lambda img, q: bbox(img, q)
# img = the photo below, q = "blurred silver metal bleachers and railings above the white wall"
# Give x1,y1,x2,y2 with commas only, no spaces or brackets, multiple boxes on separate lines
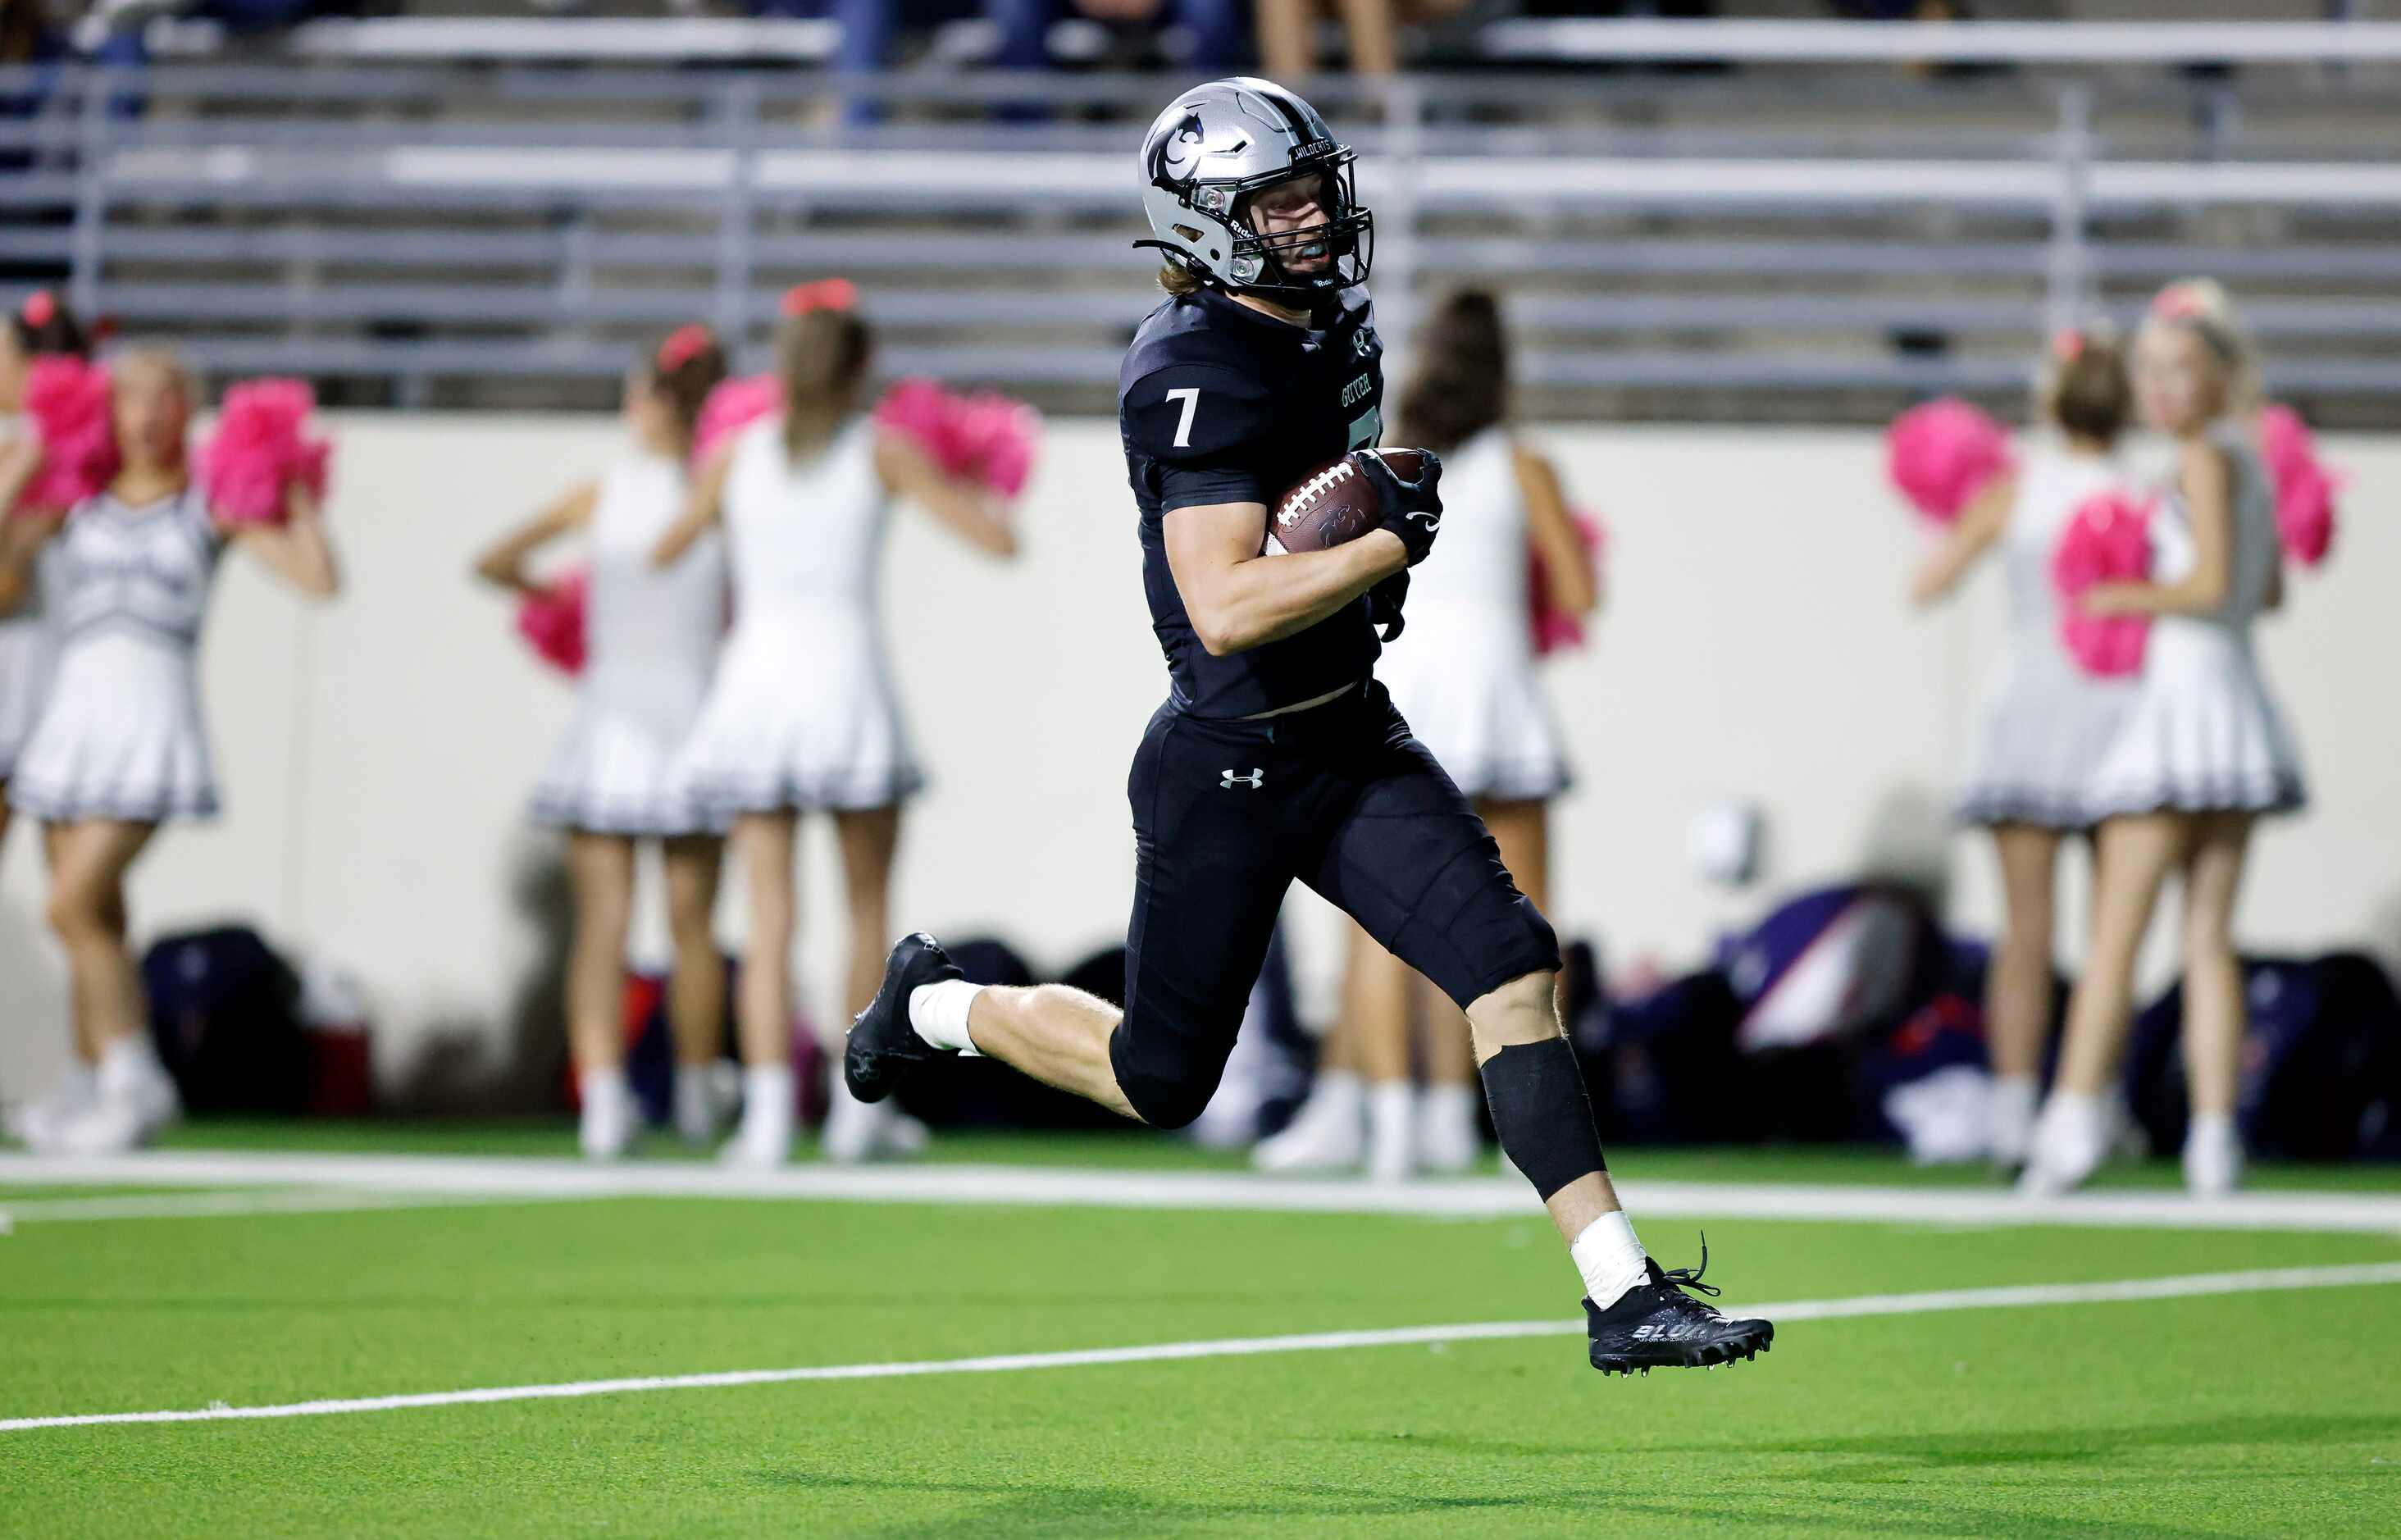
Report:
0,48,2401,423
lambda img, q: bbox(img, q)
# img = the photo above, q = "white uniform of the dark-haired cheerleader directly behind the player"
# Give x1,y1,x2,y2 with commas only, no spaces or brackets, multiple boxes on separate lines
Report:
1376,428,1570,800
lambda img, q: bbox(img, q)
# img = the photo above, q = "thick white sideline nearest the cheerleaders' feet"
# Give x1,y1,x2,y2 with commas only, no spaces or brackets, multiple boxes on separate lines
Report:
0,1150,2401,1235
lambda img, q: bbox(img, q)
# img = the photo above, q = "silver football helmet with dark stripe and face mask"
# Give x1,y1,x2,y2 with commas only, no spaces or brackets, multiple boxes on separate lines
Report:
1136,75,1376,305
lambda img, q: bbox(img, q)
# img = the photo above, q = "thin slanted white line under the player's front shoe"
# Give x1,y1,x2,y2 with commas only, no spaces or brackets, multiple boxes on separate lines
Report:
0,1261,2401,1432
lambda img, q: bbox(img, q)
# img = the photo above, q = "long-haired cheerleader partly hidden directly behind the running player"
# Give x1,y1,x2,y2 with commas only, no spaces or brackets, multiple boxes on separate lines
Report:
1255,291,1599,1180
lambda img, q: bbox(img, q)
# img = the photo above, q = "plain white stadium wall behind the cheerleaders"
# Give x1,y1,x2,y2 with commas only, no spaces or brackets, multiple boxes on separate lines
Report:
0,416,2401,1103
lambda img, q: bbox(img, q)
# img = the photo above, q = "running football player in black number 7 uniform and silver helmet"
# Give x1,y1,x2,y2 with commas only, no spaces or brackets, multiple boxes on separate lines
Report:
845,77,1775,1372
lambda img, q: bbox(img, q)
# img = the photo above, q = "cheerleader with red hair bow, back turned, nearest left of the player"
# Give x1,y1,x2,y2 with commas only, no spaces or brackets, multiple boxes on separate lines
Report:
653,279,1016,1165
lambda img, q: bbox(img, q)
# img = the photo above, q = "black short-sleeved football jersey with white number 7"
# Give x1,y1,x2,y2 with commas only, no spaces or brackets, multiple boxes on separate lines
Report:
1117,289,1383,716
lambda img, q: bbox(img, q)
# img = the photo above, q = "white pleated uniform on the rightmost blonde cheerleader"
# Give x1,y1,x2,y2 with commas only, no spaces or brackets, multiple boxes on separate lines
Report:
2093,426,2305,817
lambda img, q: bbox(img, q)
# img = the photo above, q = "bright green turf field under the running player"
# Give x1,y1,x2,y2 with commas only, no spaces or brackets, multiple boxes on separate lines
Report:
0,1127,2401,1538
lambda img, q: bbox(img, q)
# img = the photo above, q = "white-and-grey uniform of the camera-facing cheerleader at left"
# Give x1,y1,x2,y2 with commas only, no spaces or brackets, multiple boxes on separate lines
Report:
10,485,223,824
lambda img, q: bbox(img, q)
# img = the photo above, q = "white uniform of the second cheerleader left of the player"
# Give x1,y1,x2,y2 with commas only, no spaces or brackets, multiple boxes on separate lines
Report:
533,454,725,838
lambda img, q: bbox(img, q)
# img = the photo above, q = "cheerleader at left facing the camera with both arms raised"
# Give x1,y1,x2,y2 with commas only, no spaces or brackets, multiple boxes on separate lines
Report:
0,351,339,1153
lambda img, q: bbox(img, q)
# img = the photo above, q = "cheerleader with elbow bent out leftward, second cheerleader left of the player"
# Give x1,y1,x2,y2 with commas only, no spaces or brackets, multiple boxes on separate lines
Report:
476,326,725,1160
